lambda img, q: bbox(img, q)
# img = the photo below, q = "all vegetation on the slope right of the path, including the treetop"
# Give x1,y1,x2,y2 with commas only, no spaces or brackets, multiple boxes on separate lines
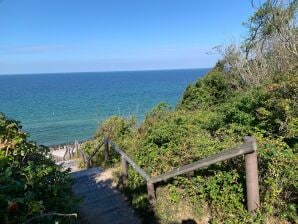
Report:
80,0,298,223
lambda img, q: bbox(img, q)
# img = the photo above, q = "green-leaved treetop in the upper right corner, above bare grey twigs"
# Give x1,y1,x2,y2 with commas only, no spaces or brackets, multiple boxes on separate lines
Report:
244,0,298,58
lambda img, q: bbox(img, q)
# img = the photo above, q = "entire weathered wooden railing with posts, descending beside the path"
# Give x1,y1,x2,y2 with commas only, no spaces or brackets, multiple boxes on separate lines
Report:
81,137,260,212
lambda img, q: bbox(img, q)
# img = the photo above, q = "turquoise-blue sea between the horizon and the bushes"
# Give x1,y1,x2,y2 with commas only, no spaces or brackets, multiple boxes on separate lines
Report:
0,69,208,145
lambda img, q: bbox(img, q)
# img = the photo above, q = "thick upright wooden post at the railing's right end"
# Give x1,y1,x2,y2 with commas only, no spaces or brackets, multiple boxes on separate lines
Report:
244,136,260,213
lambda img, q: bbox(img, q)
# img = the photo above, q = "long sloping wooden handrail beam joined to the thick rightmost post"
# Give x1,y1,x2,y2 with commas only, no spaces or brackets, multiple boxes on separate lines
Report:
150,142,256,183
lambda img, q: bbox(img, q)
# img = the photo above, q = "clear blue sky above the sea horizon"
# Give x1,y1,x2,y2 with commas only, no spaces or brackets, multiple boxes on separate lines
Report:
0,0,253,74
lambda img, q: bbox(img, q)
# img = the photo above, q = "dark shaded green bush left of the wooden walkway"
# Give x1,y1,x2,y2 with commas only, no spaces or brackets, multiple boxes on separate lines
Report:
0,113,76,224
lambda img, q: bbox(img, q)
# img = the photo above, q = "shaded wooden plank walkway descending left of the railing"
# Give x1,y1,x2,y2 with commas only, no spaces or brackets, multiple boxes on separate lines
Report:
72,168,141,224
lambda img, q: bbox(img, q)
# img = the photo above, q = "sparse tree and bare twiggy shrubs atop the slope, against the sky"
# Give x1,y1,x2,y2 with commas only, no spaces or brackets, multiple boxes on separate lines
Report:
219,0,298,85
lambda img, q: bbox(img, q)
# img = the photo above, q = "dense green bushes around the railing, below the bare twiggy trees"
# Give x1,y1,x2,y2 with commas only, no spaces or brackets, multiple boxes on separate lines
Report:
83,69,298,223
